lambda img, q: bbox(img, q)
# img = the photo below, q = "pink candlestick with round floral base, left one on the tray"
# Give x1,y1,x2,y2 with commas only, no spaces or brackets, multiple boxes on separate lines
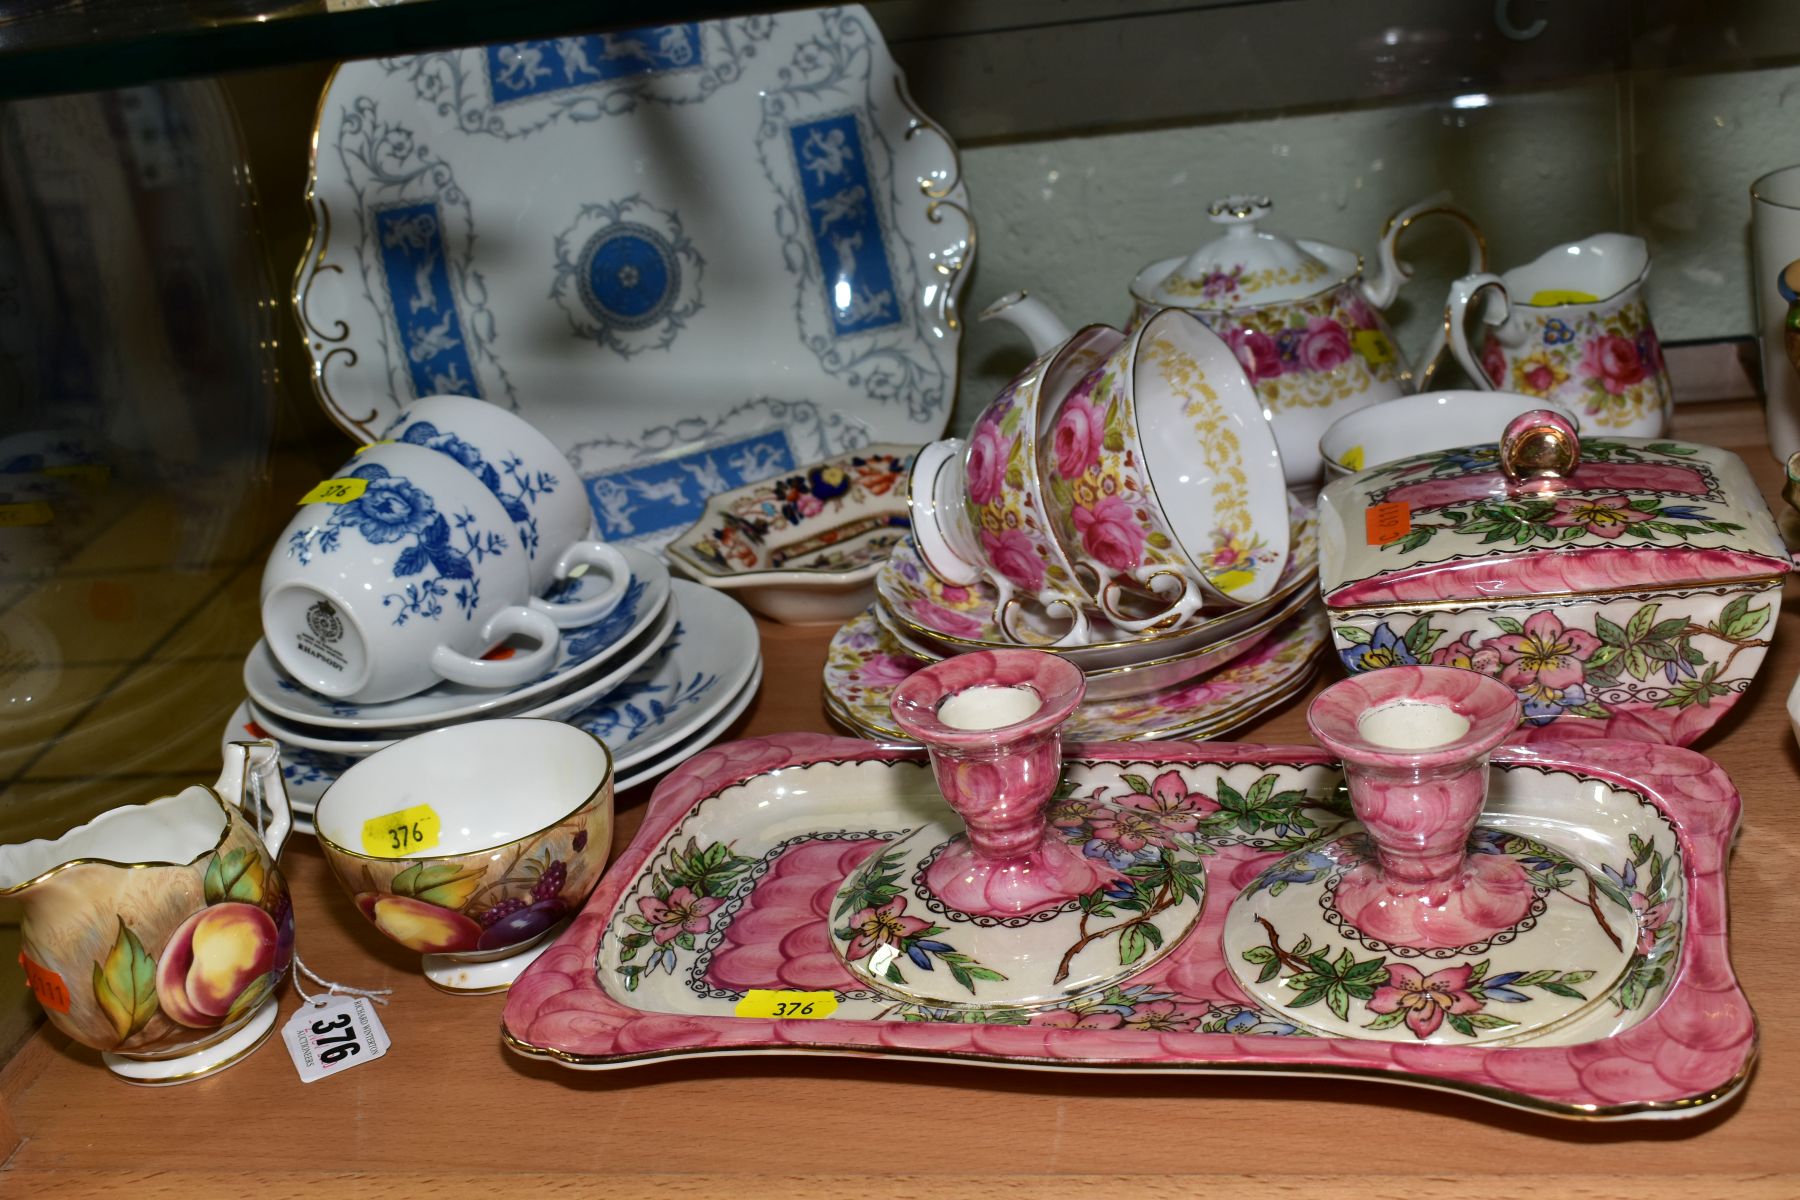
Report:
833,649,1206,1007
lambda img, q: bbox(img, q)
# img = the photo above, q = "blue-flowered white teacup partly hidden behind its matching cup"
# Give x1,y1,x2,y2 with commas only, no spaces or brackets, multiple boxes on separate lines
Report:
382,396,632,630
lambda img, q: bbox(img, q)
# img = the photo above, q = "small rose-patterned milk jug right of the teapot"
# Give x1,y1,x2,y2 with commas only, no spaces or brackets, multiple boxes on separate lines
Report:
1445,234,1674,437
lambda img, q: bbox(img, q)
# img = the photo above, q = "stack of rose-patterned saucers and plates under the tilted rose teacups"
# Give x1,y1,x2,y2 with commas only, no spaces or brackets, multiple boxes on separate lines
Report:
824,498,1327,741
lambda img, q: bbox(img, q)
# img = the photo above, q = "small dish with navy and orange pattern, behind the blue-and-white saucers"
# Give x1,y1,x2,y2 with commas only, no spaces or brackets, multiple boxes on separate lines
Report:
664,444,918,624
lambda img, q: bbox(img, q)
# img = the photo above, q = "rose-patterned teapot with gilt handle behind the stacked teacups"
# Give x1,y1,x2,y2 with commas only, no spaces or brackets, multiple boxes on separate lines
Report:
985,194,1487,488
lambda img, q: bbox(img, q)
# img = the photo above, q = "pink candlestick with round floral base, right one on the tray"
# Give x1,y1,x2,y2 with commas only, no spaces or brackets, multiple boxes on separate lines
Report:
1224,666,1636,1042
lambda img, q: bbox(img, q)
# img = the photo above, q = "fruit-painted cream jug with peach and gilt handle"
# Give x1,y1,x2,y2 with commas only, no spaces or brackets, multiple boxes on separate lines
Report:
0,741,293,1083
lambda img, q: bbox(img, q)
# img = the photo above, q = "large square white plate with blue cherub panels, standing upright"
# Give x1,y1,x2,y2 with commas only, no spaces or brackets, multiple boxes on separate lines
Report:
295,5,974,547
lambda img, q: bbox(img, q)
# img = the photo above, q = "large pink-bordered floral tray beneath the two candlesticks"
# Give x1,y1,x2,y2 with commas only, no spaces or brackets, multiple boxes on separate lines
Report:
504,734,1757,1119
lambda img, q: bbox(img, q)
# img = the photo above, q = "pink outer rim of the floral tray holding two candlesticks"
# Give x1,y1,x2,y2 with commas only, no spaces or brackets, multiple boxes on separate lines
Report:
502,732,1757,1119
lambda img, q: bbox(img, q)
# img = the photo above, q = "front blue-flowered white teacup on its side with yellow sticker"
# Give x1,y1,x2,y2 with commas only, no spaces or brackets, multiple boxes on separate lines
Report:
263,444,558,703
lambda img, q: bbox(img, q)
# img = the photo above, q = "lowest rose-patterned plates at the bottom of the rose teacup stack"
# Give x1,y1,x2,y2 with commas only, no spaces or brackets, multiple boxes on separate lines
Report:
824,603,1328,745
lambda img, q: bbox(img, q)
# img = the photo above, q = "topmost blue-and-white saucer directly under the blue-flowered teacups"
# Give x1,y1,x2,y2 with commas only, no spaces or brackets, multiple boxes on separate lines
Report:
243,545,670,732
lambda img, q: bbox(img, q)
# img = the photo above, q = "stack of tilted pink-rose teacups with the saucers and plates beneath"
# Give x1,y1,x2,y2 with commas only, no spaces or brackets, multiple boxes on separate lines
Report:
824,309,1325,741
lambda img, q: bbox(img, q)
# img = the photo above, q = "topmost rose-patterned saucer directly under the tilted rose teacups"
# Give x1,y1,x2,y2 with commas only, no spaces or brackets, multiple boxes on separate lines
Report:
875,493,1319,671
